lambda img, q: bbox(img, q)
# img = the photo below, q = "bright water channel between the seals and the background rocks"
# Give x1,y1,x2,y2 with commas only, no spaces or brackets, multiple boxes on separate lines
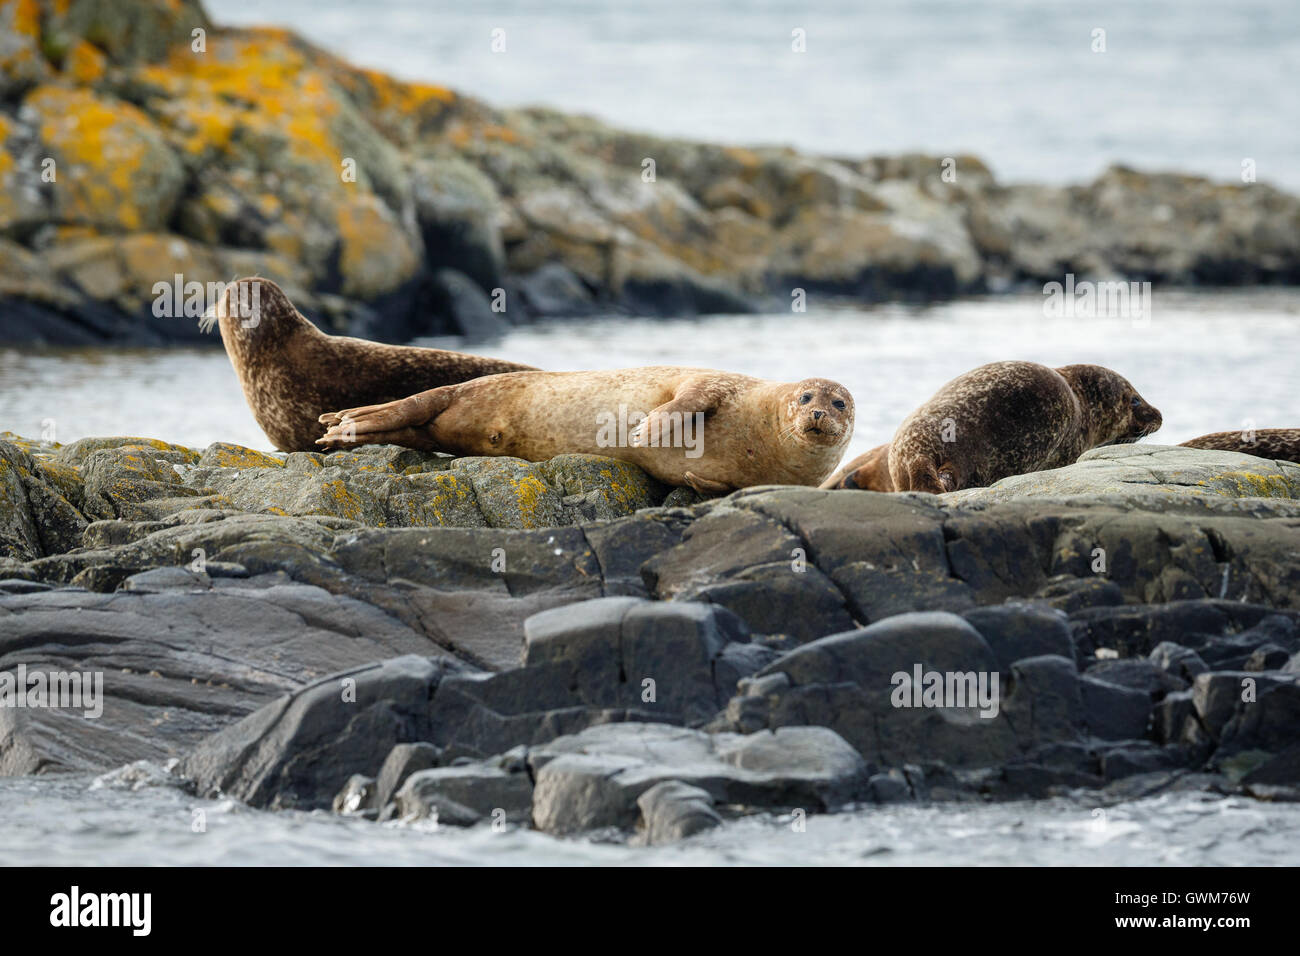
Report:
0,289,1300,455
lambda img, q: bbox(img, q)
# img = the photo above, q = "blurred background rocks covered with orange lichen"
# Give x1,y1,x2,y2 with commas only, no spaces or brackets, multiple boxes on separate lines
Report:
0,0,1300,345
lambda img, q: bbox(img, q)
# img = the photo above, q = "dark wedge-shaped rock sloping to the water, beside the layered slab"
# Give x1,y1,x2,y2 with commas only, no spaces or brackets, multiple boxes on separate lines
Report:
179,656,454,809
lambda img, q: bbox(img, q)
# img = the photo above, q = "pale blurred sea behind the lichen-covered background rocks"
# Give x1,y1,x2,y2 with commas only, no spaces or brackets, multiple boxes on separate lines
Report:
205,0,1300,190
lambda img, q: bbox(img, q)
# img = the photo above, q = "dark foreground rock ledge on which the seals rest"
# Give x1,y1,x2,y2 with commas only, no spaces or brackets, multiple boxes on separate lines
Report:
0,438,1300,843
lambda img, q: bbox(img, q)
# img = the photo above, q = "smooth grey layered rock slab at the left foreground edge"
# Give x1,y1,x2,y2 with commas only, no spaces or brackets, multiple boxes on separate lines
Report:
0,568,447,780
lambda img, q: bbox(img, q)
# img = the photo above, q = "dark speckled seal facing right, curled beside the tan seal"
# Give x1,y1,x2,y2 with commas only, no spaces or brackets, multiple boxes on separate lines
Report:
889,362,1161,494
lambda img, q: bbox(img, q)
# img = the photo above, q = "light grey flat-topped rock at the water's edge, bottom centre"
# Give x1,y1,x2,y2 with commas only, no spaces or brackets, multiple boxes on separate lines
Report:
529,723,866,835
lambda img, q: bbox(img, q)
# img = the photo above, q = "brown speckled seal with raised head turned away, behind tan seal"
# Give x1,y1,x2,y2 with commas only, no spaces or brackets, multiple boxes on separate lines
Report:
202,277,530,451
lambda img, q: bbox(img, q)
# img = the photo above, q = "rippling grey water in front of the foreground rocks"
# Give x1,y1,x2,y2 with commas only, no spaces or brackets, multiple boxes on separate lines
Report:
0,775,1300,866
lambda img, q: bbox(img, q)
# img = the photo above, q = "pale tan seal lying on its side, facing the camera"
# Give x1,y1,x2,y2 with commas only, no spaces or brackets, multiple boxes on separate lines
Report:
319,365,853,494
